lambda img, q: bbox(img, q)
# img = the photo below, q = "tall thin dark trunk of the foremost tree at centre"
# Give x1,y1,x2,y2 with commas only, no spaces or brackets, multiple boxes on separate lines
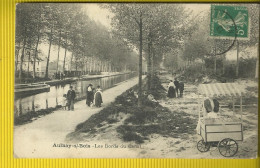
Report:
138,13,143,107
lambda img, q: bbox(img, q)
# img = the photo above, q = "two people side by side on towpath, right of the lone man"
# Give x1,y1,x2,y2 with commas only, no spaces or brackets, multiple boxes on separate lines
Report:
86,84,103,107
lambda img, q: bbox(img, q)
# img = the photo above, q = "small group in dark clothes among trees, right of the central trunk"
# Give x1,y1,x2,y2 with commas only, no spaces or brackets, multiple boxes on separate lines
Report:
167,78,184,98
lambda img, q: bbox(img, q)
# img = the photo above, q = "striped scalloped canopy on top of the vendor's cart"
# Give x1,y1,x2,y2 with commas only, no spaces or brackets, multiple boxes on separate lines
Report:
198,83,245,97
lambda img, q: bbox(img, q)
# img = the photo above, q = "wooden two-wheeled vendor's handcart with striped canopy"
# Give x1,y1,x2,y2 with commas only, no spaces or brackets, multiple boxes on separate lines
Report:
197,83,243,157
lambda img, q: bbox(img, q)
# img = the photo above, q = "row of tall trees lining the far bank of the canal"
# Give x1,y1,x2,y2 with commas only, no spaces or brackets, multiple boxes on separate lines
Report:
15,3,136,78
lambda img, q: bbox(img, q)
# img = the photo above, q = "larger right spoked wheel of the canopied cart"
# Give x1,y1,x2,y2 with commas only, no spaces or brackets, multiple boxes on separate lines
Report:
218,138,238,157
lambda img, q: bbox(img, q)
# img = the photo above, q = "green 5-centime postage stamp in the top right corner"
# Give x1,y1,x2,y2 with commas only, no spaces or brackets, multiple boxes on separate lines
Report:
210,5,249,38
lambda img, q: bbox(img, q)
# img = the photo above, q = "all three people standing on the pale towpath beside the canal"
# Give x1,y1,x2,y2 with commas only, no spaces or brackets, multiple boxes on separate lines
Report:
62,84,103,111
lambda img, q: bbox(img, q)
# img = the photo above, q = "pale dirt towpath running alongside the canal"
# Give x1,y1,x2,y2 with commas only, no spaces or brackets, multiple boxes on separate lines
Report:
14,78,142,158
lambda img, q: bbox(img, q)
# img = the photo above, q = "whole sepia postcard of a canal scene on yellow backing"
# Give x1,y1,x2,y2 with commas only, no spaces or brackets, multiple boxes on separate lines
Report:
13,3,260,159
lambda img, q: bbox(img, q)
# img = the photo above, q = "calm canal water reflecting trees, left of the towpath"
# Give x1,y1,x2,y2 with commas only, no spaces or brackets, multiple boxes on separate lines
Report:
14,73,136,117
